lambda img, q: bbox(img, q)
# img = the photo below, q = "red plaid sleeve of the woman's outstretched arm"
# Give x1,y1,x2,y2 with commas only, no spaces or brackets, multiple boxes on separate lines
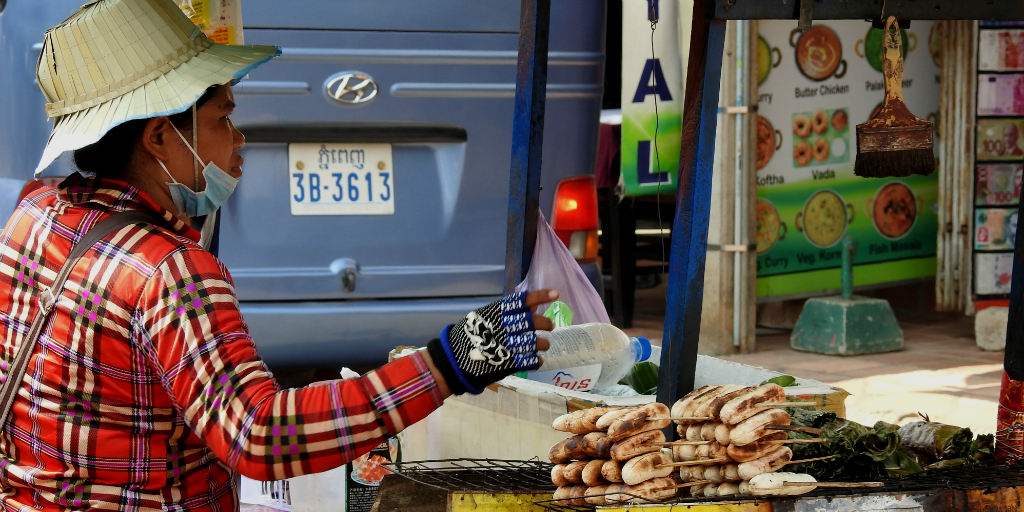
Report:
135,249,442,480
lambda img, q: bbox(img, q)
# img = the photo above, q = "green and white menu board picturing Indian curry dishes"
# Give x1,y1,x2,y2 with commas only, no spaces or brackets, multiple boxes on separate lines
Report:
756,20,937,298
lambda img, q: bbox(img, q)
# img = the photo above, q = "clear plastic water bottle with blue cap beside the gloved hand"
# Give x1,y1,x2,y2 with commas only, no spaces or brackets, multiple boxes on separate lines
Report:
537,324,650,389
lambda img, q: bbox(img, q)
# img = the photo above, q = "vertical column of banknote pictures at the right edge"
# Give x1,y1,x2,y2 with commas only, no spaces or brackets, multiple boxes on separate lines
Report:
973,23,1024,300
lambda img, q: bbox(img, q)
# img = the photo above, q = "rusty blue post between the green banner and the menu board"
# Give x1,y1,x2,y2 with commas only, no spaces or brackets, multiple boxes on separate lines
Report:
657,1,725,407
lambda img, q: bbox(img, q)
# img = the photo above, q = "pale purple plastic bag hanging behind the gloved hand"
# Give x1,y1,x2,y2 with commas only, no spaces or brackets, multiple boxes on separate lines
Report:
515,208,611,325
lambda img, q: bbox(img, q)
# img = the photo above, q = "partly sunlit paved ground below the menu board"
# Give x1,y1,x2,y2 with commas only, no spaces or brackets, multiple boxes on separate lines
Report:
628,282,1004,432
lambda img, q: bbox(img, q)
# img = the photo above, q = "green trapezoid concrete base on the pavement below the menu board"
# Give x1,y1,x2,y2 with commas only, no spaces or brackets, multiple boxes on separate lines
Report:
790,296,903,355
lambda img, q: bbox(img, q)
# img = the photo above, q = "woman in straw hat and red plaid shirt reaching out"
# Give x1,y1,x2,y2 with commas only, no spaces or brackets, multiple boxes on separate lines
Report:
0,0,557,510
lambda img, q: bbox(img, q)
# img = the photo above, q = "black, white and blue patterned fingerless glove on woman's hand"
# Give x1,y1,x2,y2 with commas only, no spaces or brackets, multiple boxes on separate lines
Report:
427,293,541,394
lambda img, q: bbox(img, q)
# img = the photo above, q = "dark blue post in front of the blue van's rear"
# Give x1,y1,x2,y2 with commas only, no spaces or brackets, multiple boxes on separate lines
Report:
505,0,551,294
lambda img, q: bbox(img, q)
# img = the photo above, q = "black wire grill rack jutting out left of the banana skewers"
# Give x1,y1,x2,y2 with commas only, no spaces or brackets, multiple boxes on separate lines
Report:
382,459,557,493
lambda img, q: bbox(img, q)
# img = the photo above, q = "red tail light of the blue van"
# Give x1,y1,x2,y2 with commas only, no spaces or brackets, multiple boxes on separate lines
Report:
551,176,597,263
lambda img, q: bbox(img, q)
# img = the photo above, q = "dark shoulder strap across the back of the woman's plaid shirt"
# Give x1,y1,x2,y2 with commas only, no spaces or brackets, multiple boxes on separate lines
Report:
0,210,160,428
